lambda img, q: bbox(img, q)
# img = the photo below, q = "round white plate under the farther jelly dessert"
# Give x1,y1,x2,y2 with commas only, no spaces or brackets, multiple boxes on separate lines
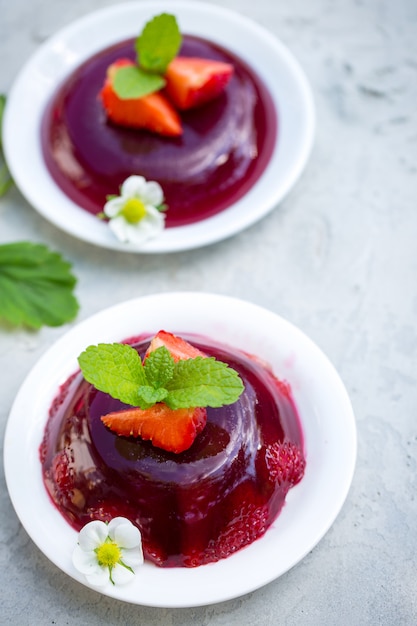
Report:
4,0,314,253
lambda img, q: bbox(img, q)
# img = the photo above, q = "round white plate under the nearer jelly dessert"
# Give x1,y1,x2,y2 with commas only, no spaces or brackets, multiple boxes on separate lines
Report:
4,292,356,607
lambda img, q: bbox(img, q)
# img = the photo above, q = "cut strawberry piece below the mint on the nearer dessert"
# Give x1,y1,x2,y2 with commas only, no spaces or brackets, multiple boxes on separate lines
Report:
101,402,207,454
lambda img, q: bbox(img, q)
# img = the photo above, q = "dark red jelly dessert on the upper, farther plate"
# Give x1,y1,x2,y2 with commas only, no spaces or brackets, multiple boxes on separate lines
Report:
41,35,277,227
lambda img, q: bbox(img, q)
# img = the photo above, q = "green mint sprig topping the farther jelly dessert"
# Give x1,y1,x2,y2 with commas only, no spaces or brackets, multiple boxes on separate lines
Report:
113,13,182,100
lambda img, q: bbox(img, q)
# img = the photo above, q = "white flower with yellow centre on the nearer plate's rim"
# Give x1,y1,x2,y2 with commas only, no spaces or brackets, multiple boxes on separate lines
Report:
72,517,143,587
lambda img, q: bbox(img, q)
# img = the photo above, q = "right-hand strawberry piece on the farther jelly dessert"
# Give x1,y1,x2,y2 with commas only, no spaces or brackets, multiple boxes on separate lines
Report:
165,57,234,111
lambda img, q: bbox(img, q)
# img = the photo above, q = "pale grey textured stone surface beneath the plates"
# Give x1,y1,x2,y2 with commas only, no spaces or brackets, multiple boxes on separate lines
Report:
0,0,417,626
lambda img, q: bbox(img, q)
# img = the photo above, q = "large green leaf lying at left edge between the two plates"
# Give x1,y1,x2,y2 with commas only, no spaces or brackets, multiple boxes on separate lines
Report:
0,242,79,329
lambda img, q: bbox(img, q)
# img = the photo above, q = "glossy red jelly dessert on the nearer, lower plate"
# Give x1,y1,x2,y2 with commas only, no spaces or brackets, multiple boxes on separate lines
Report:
40,337,305,567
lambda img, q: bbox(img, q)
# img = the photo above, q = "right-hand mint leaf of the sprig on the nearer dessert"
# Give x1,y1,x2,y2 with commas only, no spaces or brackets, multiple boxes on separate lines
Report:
164,357,243,409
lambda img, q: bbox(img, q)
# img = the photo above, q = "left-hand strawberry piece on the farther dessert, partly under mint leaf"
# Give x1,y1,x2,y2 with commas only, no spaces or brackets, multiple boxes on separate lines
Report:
100,59,182,137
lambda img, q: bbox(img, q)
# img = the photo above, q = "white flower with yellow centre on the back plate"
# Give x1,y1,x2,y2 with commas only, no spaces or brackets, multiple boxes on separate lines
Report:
103,176,165,245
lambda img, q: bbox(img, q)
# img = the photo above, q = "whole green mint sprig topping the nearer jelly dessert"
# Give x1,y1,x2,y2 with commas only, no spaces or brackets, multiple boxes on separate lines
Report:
78,343,244,409
